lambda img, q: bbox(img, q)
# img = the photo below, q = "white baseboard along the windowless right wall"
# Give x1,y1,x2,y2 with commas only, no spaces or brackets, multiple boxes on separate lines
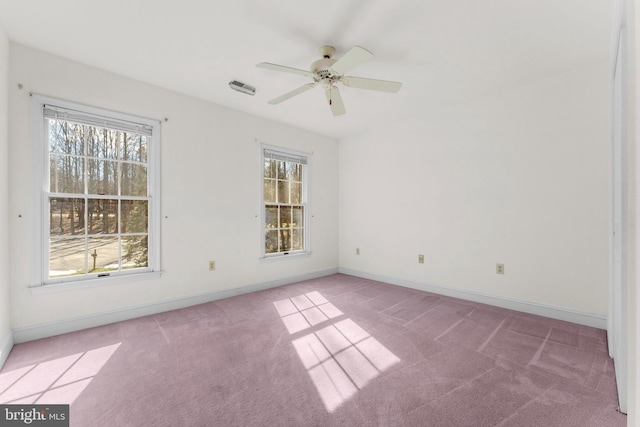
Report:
339,268,607,329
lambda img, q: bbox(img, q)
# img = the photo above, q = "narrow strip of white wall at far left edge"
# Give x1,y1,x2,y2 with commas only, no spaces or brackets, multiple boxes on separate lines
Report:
0,21,13,367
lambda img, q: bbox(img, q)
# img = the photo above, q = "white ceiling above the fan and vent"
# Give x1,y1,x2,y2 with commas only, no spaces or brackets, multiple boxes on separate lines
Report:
0,0,614,138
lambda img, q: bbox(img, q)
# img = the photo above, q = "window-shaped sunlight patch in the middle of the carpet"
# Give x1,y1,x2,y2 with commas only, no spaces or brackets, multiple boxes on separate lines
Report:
273,291,400,412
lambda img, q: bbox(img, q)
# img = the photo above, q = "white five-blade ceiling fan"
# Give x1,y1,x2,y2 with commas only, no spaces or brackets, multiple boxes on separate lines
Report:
256,46,402,116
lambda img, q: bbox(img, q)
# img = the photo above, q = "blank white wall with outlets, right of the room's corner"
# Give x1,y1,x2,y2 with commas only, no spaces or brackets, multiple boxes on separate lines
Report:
339,63,611,320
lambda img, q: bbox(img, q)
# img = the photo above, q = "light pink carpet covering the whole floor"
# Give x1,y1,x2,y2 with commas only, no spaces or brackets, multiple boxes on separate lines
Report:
0,274,626,427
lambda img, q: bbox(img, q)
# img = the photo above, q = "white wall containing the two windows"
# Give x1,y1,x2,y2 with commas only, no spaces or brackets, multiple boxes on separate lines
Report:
8,43,338,338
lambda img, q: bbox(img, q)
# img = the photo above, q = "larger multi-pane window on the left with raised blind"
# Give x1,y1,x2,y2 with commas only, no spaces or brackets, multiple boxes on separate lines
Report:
34,97,160,284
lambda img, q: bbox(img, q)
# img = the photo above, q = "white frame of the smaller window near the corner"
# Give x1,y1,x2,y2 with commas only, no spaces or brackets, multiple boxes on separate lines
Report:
259,144,311,260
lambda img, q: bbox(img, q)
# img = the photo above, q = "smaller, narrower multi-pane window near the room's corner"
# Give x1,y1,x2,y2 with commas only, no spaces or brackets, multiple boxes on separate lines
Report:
262,148,308,256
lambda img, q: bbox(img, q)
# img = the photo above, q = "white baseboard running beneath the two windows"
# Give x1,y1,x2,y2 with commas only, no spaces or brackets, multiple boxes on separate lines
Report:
13,268,338,343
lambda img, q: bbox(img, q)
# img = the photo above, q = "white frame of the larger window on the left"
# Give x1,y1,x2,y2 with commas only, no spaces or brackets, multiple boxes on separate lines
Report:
30,94,161,291
